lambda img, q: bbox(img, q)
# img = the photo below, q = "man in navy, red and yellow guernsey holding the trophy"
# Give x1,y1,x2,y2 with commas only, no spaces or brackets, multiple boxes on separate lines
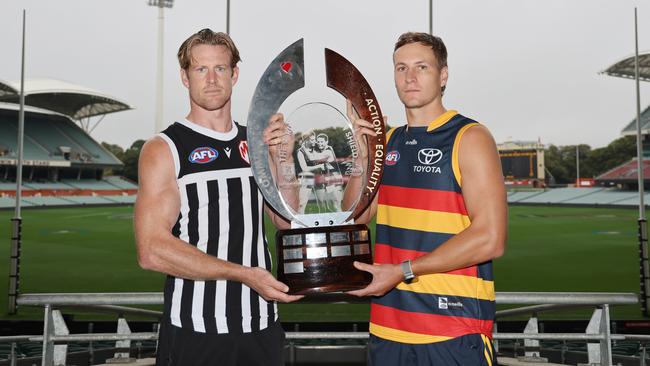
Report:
348,33,507,366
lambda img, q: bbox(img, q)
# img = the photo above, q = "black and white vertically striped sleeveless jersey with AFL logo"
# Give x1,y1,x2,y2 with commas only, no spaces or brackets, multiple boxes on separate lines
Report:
159,120,277,334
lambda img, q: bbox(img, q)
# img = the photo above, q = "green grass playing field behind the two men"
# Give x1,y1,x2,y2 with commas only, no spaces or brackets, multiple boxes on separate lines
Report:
0,206,641,321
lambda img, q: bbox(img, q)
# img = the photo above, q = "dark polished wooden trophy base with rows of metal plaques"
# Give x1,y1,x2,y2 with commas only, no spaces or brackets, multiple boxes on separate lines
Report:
275,225,372,299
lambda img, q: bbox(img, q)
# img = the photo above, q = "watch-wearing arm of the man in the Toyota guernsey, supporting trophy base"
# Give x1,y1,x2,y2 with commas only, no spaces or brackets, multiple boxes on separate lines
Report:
350,125,508,296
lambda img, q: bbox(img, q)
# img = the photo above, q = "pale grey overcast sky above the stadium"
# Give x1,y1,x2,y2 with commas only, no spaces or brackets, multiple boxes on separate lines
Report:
0,0,650,147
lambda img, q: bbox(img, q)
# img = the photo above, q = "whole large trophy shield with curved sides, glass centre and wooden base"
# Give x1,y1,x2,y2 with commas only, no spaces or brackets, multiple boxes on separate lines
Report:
247,39,385,296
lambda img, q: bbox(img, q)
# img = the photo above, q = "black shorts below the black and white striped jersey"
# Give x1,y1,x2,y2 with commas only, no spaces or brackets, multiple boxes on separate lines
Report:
156,320,284,366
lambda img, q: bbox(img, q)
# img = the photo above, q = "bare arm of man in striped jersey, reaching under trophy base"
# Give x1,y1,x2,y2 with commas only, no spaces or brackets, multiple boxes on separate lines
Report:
134,137,300,302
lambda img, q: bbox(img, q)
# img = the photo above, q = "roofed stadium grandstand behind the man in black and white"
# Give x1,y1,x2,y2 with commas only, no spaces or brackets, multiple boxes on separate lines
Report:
0,79,137,208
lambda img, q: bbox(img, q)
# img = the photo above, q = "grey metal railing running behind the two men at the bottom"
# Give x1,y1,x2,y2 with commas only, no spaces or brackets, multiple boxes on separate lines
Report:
0,292,636,366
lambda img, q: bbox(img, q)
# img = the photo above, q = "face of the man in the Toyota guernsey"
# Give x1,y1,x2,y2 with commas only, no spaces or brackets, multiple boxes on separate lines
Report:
393,42,448,108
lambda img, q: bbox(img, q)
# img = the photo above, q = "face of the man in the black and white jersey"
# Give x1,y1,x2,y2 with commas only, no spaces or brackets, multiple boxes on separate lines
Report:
181,44,239,111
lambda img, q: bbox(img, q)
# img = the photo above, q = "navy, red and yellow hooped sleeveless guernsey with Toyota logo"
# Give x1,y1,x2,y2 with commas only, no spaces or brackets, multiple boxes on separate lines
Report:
370,110,495,344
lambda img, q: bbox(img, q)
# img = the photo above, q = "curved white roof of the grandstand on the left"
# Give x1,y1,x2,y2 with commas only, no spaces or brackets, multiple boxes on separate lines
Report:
0,79,133,120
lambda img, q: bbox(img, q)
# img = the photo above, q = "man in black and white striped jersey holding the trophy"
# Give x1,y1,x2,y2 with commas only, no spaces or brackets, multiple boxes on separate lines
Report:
135,29,300,366
